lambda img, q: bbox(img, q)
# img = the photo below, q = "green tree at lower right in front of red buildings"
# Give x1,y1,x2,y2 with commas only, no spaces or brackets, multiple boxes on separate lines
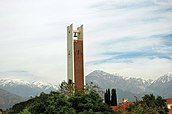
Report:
127,94,169,114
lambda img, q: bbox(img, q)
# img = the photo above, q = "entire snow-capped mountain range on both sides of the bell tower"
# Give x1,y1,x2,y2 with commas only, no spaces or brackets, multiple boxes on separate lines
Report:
0,70,172,100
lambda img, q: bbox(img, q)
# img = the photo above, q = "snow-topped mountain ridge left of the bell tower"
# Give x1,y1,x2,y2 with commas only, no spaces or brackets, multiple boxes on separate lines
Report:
0,78,58,97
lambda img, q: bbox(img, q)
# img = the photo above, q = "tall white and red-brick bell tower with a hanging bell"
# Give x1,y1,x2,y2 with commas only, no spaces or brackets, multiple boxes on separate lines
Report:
67,25,84,90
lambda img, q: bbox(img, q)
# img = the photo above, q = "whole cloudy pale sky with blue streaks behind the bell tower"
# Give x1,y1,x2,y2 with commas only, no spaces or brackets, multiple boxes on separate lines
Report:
0,0,172,83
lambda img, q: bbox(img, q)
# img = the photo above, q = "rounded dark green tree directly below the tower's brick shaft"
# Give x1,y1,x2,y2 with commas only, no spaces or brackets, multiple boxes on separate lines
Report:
68,91,115,114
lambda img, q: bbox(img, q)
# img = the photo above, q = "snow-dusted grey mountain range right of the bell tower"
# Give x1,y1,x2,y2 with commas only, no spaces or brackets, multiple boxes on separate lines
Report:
86,70,172,100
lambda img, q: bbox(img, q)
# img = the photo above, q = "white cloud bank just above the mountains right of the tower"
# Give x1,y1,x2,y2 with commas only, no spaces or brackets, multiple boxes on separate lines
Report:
86,58,172,80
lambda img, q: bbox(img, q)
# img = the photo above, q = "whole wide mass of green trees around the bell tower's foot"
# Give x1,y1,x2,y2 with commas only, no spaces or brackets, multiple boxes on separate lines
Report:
6,80,115,114
